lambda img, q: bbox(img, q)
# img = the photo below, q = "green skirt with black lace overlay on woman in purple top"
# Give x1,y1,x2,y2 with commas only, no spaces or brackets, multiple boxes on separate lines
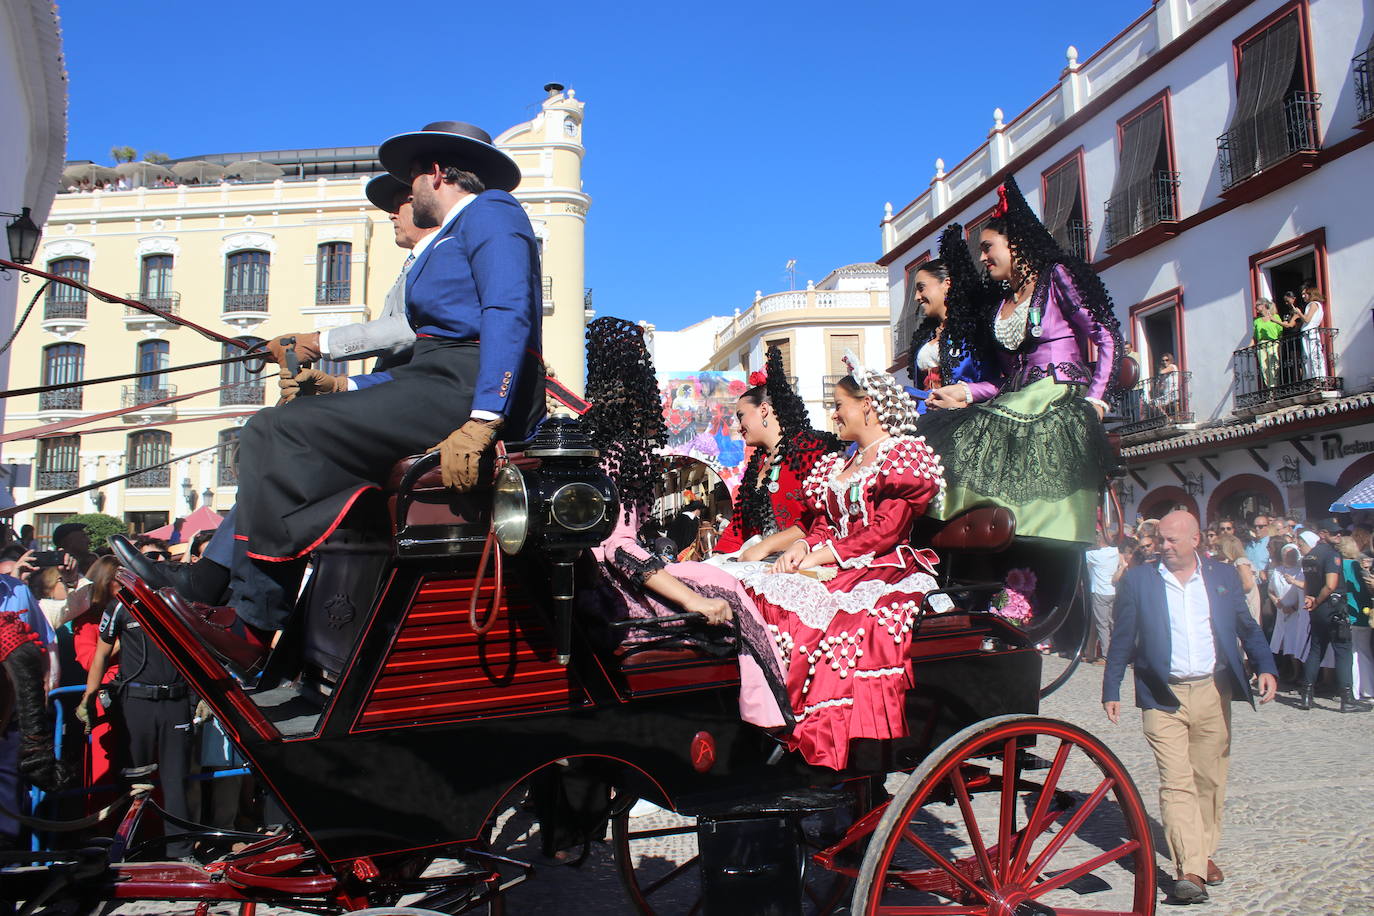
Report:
916,379,1110,544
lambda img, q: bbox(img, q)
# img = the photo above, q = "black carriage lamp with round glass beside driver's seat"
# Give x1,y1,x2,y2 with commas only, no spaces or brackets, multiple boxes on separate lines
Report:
492,417,620,665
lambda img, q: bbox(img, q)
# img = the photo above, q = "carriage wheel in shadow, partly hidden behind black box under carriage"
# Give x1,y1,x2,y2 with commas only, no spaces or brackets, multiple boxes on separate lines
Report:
610,798,853,916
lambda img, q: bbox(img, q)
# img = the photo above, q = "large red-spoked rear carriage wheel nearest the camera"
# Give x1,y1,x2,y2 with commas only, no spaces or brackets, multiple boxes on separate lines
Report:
853,715,1156,916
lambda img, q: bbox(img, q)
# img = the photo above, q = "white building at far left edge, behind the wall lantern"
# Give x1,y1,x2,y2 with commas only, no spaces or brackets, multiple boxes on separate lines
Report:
0,0,67,505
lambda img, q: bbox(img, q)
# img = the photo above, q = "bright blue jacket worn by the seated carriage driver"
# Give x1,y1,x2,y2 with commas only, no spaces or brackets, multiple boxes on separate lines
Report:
353,191,544,416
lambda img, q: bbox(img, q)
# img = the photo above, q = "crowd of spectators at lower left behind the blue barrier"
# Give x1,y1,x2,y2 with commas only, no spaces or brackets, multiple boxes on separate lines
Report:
0,523,270,858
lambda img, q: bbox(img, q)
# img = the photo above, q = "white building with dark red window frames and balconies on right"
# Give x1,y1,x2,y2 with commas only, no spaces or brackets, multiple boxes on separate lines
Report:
879,0,1374,522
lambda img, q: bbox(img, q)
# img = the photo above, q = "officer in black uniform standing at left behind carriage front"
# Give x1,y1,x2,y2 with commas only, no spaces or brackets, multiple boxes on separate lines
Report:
81,590,192,858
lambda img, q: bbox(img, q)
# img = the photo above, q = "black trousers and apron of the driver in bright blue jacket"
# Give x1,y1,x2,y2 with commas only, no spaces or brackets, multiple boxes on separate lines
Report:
231,338,544,630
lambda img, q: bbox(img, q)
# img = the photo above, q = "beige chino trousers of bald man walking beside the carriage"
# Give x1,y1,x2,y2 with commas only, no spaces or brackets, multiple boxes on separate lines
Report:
1142,677,1231,878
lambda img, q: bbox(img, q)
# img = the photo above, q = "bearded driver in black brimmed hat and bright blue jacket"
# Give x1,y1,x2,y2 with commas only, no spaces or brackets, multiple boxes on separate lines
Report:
164,121,544,673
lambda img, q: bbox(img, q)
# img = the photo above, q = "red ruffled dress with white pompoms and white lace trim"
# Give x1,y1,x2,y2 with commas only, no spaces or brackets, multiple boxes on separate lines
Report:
745,435,943,769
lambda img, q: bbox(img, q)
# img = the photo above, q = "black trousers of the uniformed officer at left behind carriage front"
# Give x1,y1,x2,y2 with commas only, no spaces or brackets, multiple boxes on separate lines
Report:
120,691,194,856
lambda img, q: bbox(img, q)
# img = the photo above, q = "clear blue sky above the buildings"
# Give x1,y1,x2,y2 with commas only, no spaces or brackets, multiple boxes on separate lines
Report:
59,0,1132,328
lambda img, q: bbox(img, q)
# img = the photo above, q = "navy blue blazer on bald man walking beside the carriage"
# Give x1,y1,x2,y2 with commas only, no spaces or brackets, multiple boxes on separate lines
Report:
1102,559,1278,713
